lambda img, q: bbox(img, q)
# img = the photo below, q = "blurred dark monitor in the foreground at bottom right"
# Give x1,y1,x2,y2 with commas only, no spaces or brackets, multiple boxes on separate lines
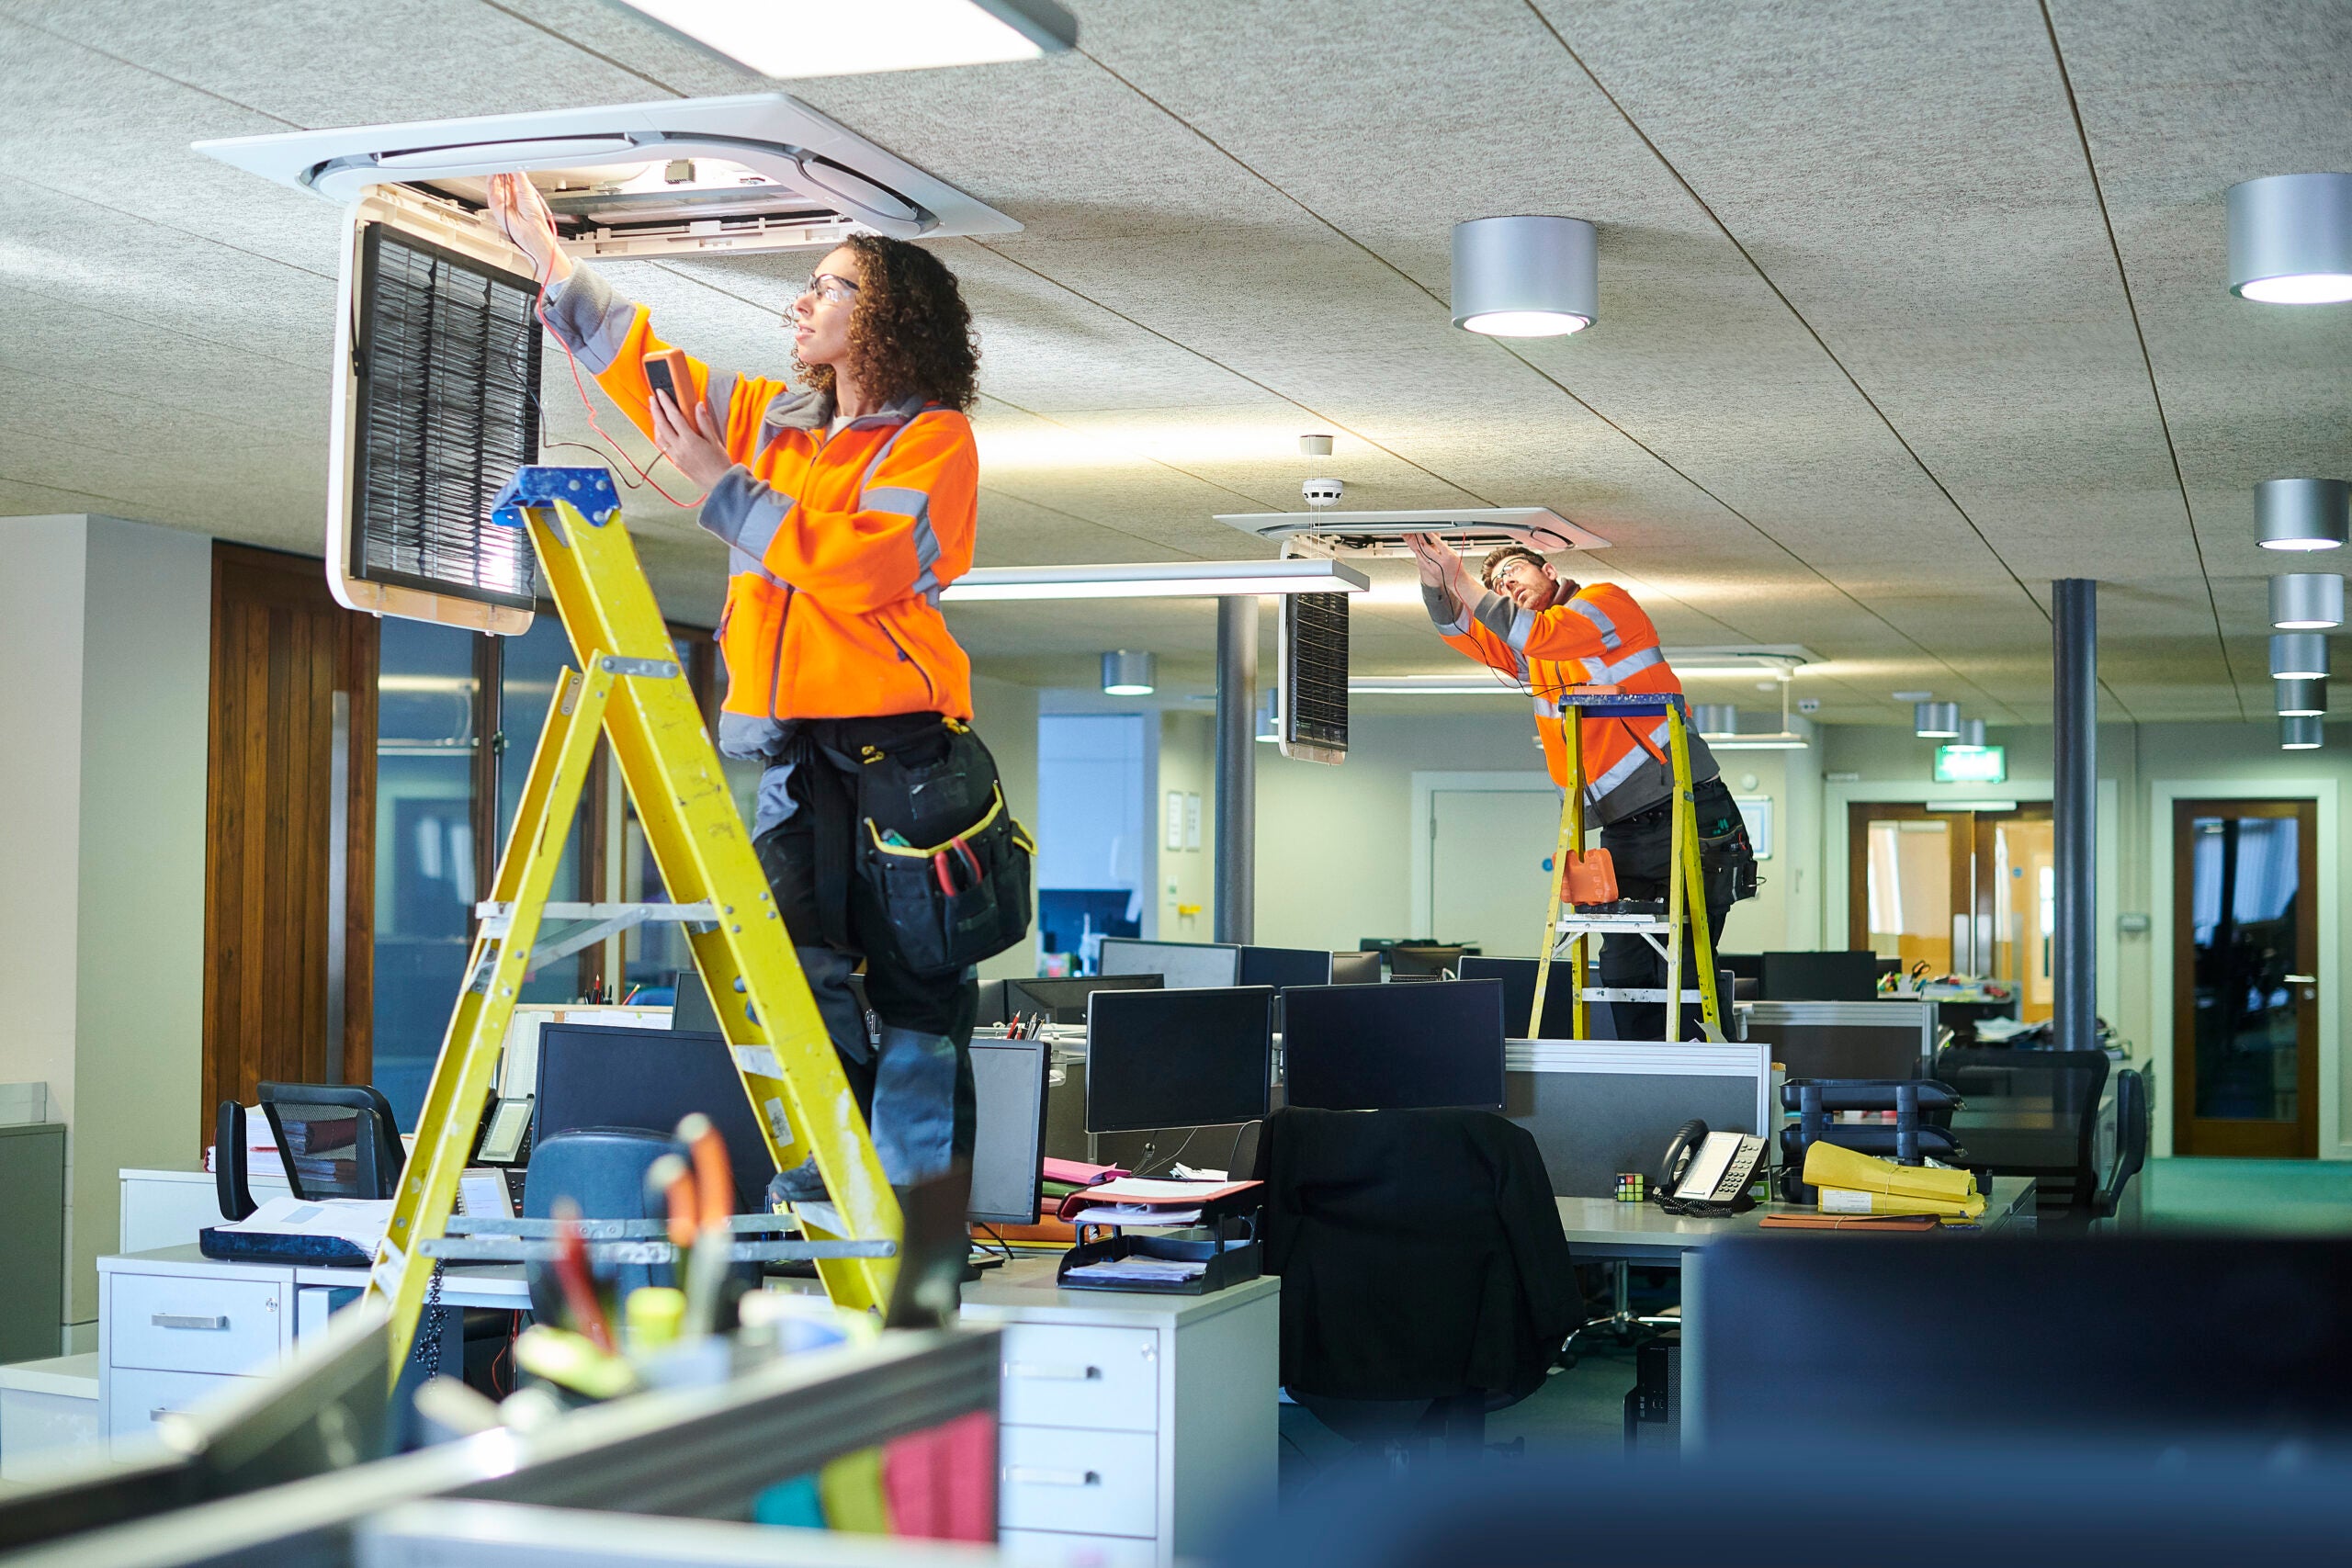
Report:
1684,1235,2352,1474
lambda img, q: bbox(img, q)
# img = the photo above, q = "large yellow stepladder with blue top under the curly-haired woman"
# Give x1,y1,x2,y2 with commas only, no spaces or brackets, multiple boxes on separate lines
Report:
367,468,900,1380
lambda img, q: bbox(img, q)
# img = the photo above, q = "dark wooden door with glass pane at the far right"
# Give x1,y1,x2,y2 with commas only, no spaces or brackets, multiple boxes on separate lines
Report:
2171,799,2319,1159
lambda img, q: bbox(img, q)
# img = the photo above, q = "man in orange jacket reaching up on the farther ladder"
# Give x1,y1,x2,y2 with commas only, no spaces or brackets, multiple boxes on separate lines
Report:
1407,534,1755,1039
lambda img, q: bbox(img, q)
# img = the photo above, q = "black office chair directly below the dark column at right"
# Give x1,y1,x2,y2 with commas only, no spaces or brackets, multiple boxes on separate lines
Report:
1936,1046,2108,1218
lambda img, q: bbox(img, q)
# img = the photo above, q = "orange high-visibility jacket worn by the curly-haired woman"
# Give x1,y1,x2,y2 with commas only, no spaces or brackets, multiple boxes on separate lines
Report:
546,265,978,757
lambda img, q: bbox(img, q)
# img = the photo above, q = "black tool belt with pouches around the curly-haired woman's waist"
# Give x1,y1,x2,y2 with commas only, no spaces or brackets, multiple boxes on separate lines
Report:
776,712,1037,976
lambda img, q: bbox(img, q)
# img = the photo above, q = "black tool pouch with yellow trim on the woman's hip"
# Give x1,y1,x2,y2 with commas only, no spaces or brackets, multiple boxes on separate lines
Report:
858,790,1037,976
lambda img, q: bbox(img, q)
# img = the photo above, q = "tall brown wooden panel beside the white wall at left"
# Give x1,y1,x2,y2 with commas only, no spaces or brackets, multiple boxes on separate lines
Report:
198,543,377,1143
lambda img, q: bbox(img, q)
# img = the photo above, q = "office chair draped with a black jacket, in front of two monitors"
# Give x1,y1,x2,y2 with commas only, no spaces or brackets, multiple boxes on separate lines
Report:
1256,1107,1585,1458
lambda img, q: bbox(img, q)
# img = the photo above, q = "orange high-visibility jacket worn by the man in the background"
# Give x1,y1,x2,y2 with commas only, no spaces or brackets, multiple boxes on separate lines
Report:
1420,583,1717,825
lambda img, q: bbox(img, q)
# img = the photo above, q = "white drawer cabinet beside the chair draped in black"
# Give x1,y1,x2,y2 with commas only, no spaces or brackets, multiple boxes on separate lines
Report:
965,1258,1282,1568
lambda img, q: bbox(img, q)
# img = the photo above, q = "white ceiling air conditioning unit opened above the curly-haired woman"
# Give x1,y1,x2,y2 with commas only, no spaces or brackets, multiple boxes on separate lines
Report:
195,92,1021,259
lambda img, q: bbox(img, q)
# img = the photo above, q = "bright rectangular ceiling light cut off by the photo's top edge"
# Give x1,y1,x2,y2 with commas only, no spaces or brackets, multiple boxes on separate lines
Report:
621,0,1077,77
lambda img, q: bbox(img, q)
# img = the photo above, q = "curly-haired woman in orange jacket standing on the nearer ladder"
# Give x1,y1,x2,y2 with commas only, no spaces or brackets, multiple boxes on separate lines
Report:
492,174,1028,1201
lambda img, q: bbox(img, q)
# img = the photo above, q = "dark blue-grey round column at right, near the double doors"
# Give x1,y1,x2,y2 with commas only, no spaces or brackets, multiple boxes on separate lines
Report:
2051,579,2098,1051
